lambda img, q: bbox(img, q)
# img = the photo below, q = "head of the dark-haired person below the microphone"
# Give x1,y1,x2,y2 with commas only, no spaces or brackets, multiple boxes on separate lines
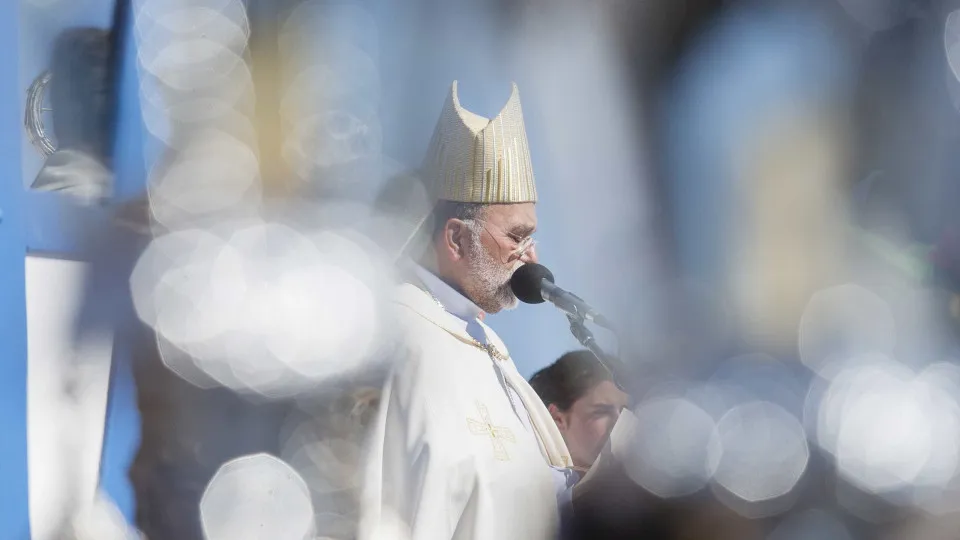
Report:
530,350,628,472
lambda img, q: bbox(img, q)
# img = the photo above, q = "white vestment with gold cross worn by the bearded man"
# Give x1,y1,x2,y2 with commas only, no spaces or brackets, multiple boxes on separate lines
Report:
359,272,569,540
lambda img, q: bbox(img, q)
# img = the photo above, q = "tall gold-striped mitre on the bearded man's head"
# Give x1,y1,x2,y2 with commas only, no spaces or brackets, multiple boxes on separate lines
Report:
422,81,537,204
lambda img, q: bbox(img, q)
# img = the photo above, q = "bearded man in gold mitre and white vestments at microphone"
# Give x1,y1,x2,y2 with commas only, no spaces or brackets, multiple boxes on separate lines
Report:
360,82,575,540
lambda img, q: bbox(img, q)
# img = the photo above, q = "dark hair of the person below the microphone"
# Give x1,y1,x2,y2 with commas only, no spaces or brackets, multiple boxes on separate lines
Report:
530,350,612,411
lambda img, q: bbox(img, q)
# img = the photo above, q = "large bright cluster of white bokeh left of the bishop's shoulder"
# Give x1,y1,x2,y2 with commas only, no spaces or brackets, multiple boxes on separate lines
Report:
131,222,383,397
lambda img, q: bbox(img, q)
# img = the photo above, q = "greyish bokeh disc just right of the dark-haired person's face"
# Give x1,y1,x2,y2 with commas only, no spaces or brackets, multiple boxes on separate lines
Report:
624,397,717,497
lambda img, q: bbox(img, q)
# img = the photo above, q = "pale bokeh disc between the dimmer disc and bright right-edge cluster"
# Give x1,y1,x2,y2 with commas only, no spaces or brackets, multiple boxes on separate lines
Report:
713,401,810,517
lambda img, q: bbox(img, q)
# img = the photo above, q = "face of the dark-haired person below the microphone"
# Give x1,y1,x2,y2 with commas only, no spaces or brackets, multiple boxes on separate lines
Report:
550,381,627,468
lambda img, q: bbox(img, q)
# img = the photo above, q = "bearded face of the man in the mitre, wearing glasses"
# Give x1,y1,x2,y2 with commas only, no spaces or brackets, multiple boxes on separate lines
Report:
462,203,537,313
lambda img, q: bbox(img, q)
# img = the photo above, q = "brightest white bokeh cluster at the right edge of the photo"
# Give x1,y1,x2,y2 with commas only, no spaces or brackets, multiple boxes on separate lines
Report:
817,357,960,495
